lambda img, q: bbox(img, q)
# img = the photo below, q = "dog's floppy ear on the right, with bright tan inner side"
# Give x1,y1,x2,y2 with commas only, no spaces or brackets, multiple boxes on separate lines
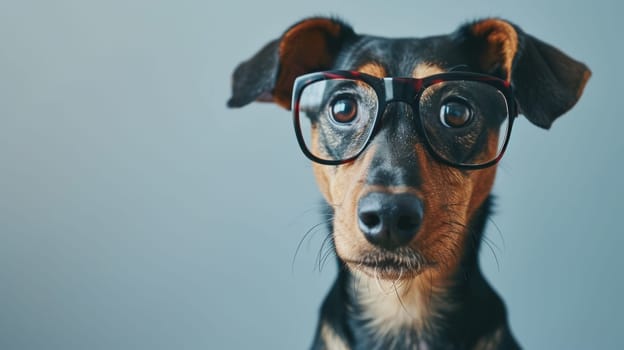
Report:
455,19,591,129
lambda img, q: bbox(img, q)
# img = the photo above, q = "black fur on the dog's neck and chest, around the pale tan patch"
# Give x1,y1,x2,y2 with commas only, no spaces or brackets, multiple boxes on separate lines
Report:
311,197,519,350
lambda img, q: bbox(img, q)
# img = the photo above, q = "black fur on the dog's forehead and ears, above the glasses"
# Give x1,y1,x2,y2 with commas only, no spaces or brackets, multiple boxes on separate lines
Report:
228,19,591,129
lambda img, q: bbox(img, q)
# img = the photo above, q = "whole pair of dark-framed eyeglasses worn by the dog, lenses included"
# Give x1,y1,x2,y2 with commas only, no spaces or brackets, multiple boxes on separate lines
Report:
292,71,517,169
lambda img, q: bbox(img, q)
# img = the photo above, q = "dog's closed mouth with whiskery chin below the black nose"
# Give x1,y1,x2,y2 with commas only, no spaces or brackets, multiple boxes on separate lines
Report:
343,248,434,280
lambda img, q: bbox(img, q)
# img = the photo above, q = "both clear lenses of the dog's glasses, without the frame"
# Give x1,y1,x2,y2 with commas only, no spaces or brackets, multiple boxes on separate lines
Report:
297,78,510,165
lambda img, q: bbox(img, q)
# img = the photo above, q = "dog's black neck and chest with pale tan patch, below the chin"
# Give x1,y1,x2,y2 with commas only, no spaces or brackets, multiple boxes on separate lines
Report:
316,201,517,349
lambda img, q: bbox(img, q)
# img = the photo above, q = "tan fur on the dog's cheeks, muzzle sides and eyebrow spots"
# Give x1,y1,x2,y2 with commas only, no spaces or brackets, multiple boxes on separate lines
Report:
312,63,496,286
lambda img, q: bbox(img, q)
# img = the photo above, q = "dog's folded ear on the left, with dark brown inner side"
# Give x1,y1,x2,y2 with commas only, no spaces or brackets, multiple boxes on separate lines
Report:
228,18,355,109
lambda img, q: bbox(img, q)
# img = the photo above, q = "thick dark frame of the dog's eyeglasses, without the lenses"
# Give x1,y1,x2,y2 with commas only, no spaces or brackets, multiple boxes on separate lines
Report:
291,70,518,169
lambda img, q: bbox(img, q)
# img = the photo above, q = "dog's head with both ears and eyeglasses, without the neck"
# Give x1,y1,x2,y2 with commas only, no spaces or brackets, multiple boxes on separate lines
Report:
228,18,590,279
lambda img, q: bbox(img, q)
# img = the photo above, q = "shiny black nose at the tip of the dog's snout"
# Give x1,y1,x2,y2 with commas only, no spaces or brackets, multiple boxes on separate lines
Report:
358,192,423,249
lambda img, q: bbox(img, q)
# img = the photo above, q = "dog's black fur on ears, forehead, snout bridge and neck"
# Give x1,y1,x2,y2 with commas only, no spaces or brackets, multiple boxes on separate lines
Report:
228,18,590,350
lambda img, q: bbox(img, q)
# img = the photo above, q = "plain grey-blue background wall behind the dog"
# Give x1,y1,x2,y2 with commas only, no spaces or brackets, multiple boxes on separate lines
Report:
0,0,624,349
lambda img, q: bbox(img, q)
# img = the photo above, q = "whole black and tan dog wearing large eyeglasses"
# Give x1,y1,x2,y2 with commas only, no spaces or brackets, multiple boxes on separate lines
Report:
228,17,591,349
